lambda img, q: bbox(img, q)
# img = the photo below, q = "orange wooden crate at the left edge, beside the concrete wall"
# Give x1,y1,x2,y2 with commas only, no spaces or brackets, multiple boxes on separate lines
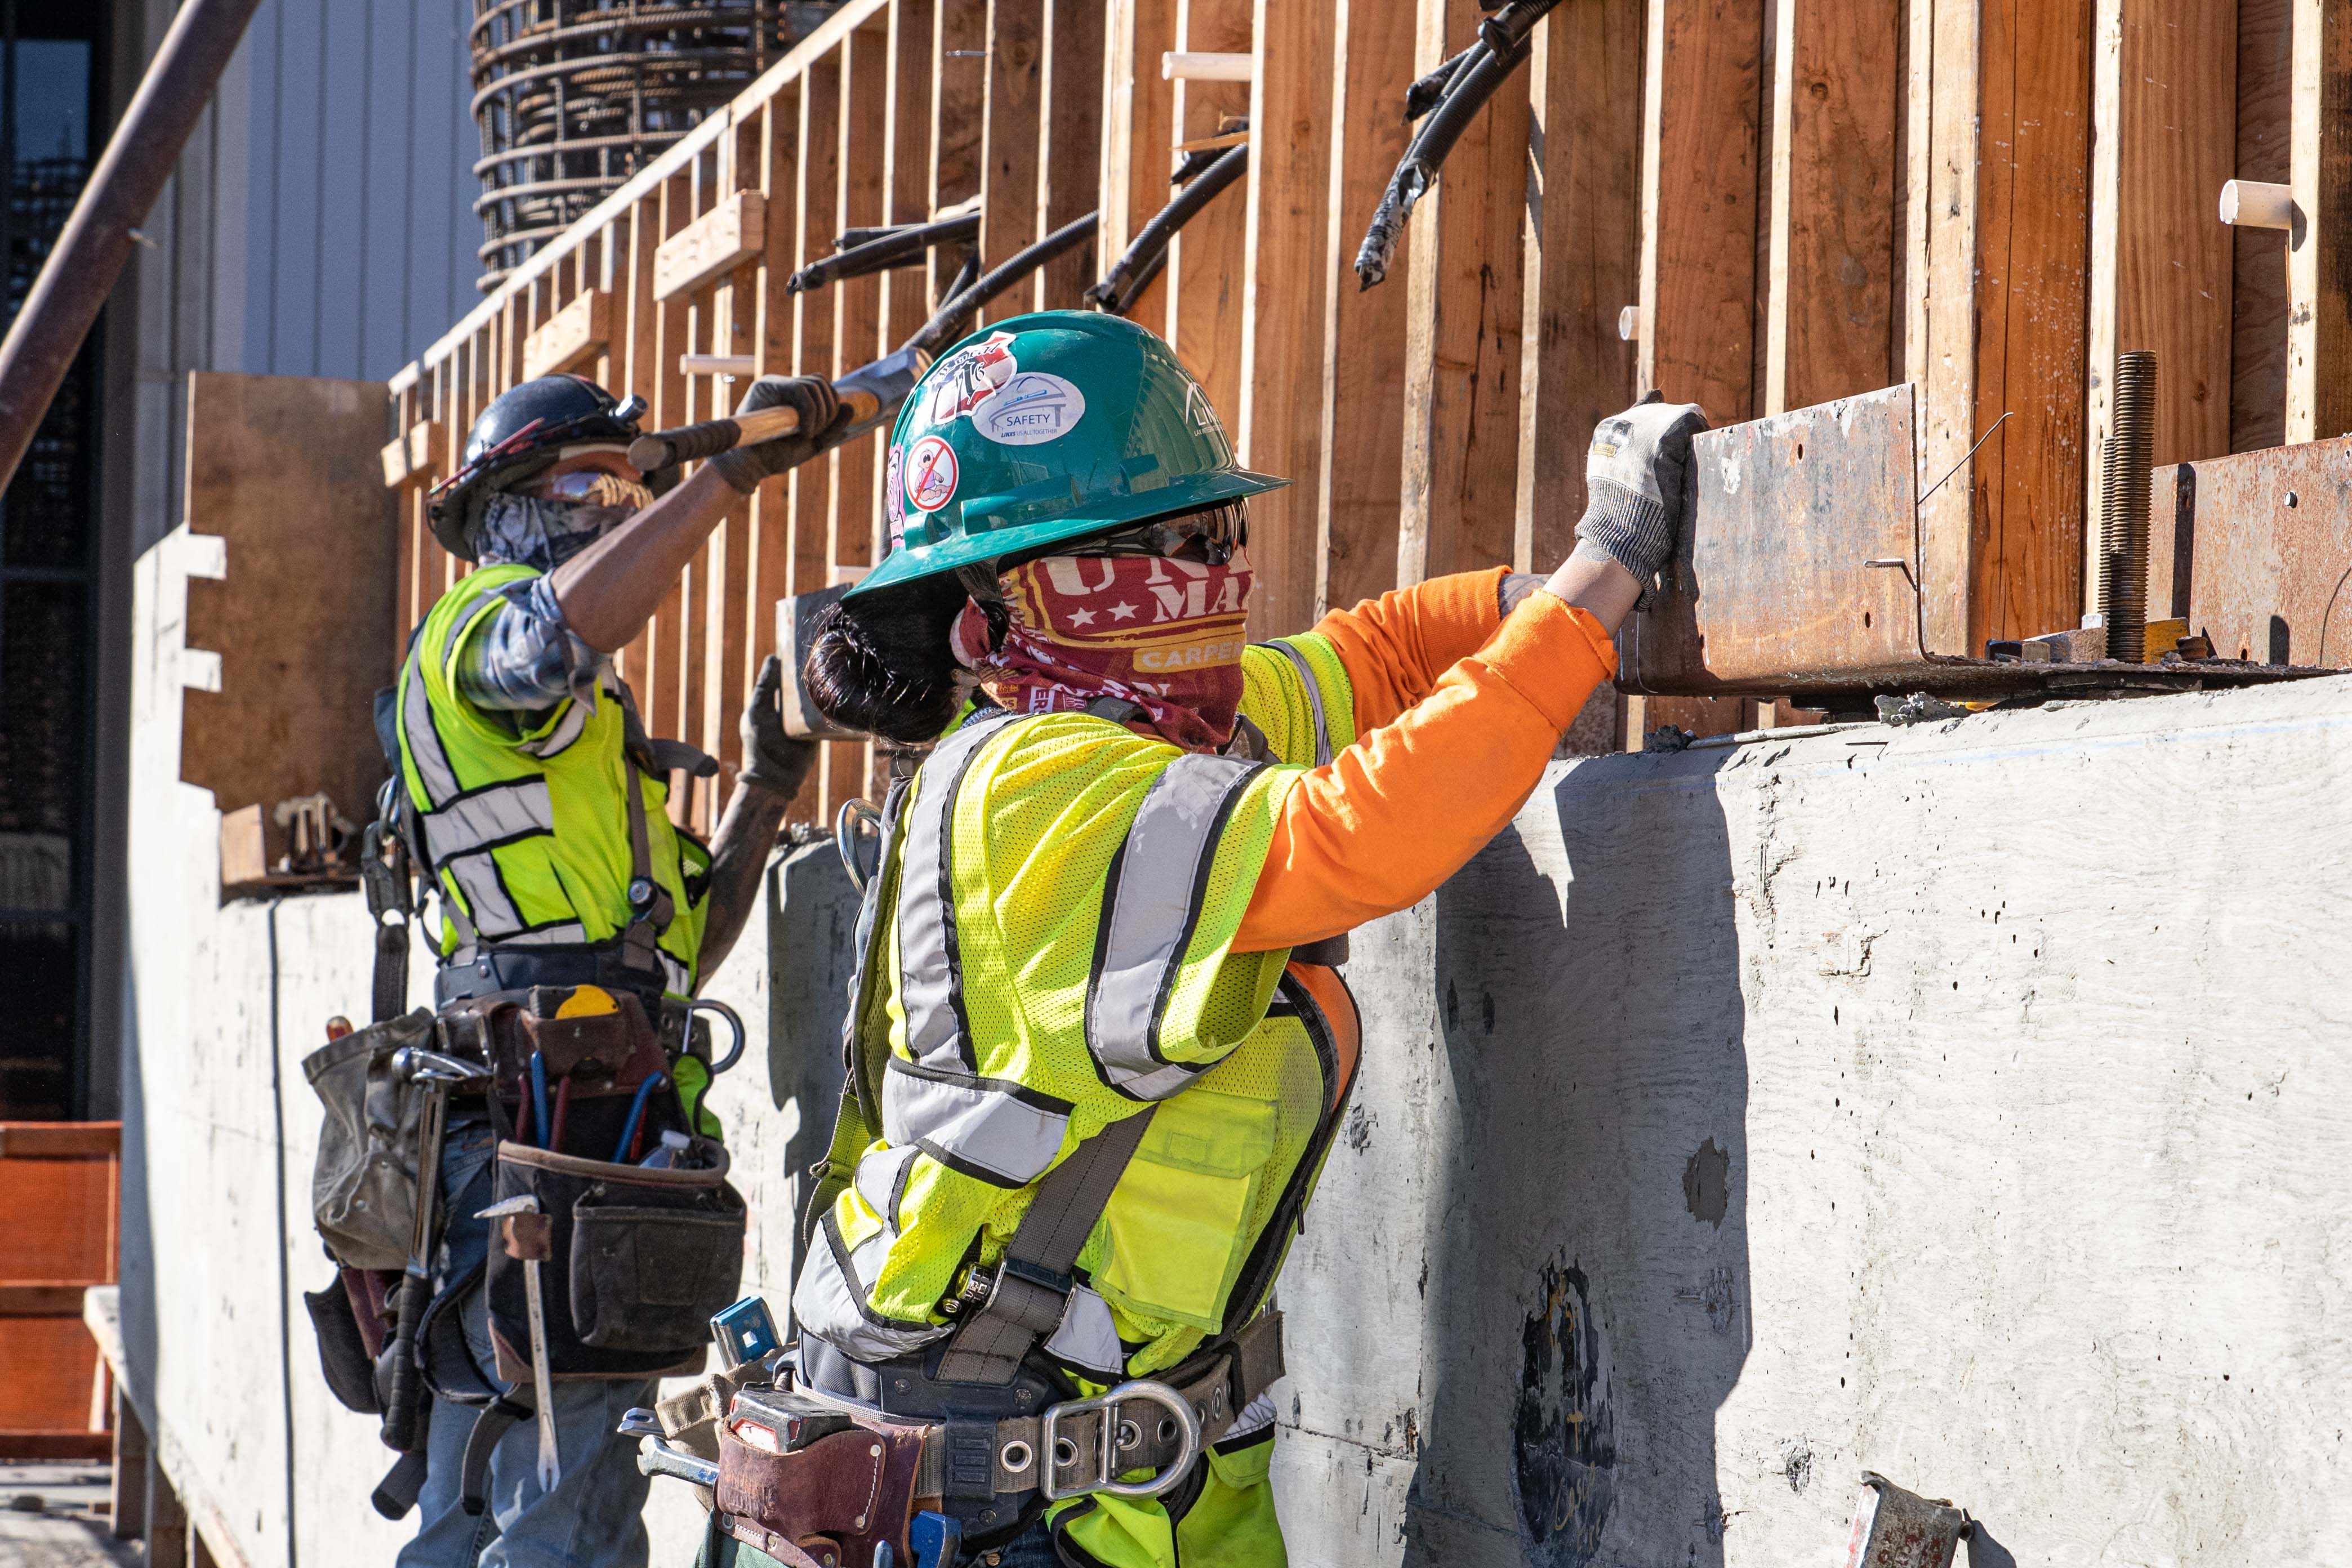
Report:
0,1121,122,1458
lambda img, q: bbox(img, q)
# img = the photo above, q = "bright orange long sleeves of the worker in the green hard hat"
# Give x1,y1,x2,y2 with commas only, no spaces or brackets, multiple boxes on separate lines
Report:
1232,569,1616,952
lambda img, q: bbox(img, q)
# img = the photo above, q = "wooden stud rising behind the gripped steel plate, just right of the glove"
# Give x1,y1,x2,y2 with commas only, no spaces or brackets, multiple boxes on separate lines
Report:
1764,0,1900,414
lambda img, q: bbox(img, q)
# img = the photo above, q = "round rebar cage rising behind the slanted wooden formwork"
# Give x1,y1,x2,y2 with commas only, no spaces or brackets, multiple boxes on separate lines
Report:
470,0,838,294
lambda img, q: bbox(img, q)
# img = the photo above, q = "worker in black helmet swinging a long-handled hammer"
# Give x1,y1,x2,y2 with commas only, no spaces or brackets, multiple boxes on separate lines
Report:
398,376,840,1568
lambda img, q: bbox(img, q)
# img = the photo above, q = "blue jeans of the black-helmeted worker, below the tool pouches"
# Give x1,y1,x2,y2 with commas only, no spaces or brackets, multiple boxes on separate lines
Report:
398,1121,653,1568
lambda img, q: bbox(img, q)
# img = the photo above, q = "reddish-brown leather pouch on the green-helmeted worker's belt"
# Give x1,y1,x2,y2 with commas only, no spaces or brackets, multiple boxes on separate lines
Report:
710,1410,938,1568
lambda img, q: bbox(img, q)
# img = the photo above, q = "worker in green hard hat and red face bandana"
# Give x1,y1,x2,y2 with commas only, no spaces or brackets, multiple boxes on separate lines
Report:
712,313,1705,1568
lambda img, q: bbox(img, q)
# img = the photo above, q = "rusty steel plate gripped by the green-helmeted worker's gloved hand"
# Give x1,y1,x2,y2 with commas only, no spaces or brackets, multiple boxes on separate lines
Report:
1618,386,1926,696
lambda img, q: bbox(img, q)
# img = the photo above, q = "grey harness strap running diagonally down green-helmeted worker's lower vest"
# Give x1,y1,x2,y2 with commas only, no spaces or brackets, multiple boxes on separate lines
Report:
938,1107,1157,1384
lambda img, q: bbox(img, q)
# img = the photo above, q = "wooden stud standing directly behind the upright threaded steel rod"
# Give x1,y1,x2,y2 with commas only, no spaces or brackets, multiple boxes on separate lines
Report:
2082,0,2237,609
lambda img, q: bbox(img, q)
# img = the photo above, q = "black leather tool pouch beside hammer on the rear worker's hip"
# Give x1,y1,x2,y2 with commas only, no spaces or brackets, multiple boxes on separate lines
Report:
475,1140,746,1382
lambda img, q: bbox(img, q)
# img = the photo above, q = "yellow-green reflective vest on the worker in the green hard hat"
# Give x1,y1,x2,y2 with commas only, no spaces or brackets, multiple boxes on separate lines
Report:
792,635,1355,1563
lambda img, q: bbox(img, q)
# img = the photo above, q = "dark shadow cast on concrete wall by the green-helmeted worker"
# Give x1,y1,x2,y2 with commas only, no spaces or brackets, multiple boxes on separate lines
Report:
1404,750,1752,1568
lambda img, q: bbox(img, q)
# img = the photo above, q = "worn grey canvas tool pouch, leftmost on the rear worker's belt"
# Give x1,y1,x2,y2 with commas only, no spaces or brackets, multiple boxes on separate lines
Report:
301,1009,433,1269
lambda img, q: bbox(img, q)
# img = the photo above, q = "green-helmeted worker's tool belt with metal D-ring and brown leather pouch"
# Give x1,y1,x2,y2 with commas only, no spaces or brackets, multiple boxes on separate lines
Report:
687,1312,1282,1568
